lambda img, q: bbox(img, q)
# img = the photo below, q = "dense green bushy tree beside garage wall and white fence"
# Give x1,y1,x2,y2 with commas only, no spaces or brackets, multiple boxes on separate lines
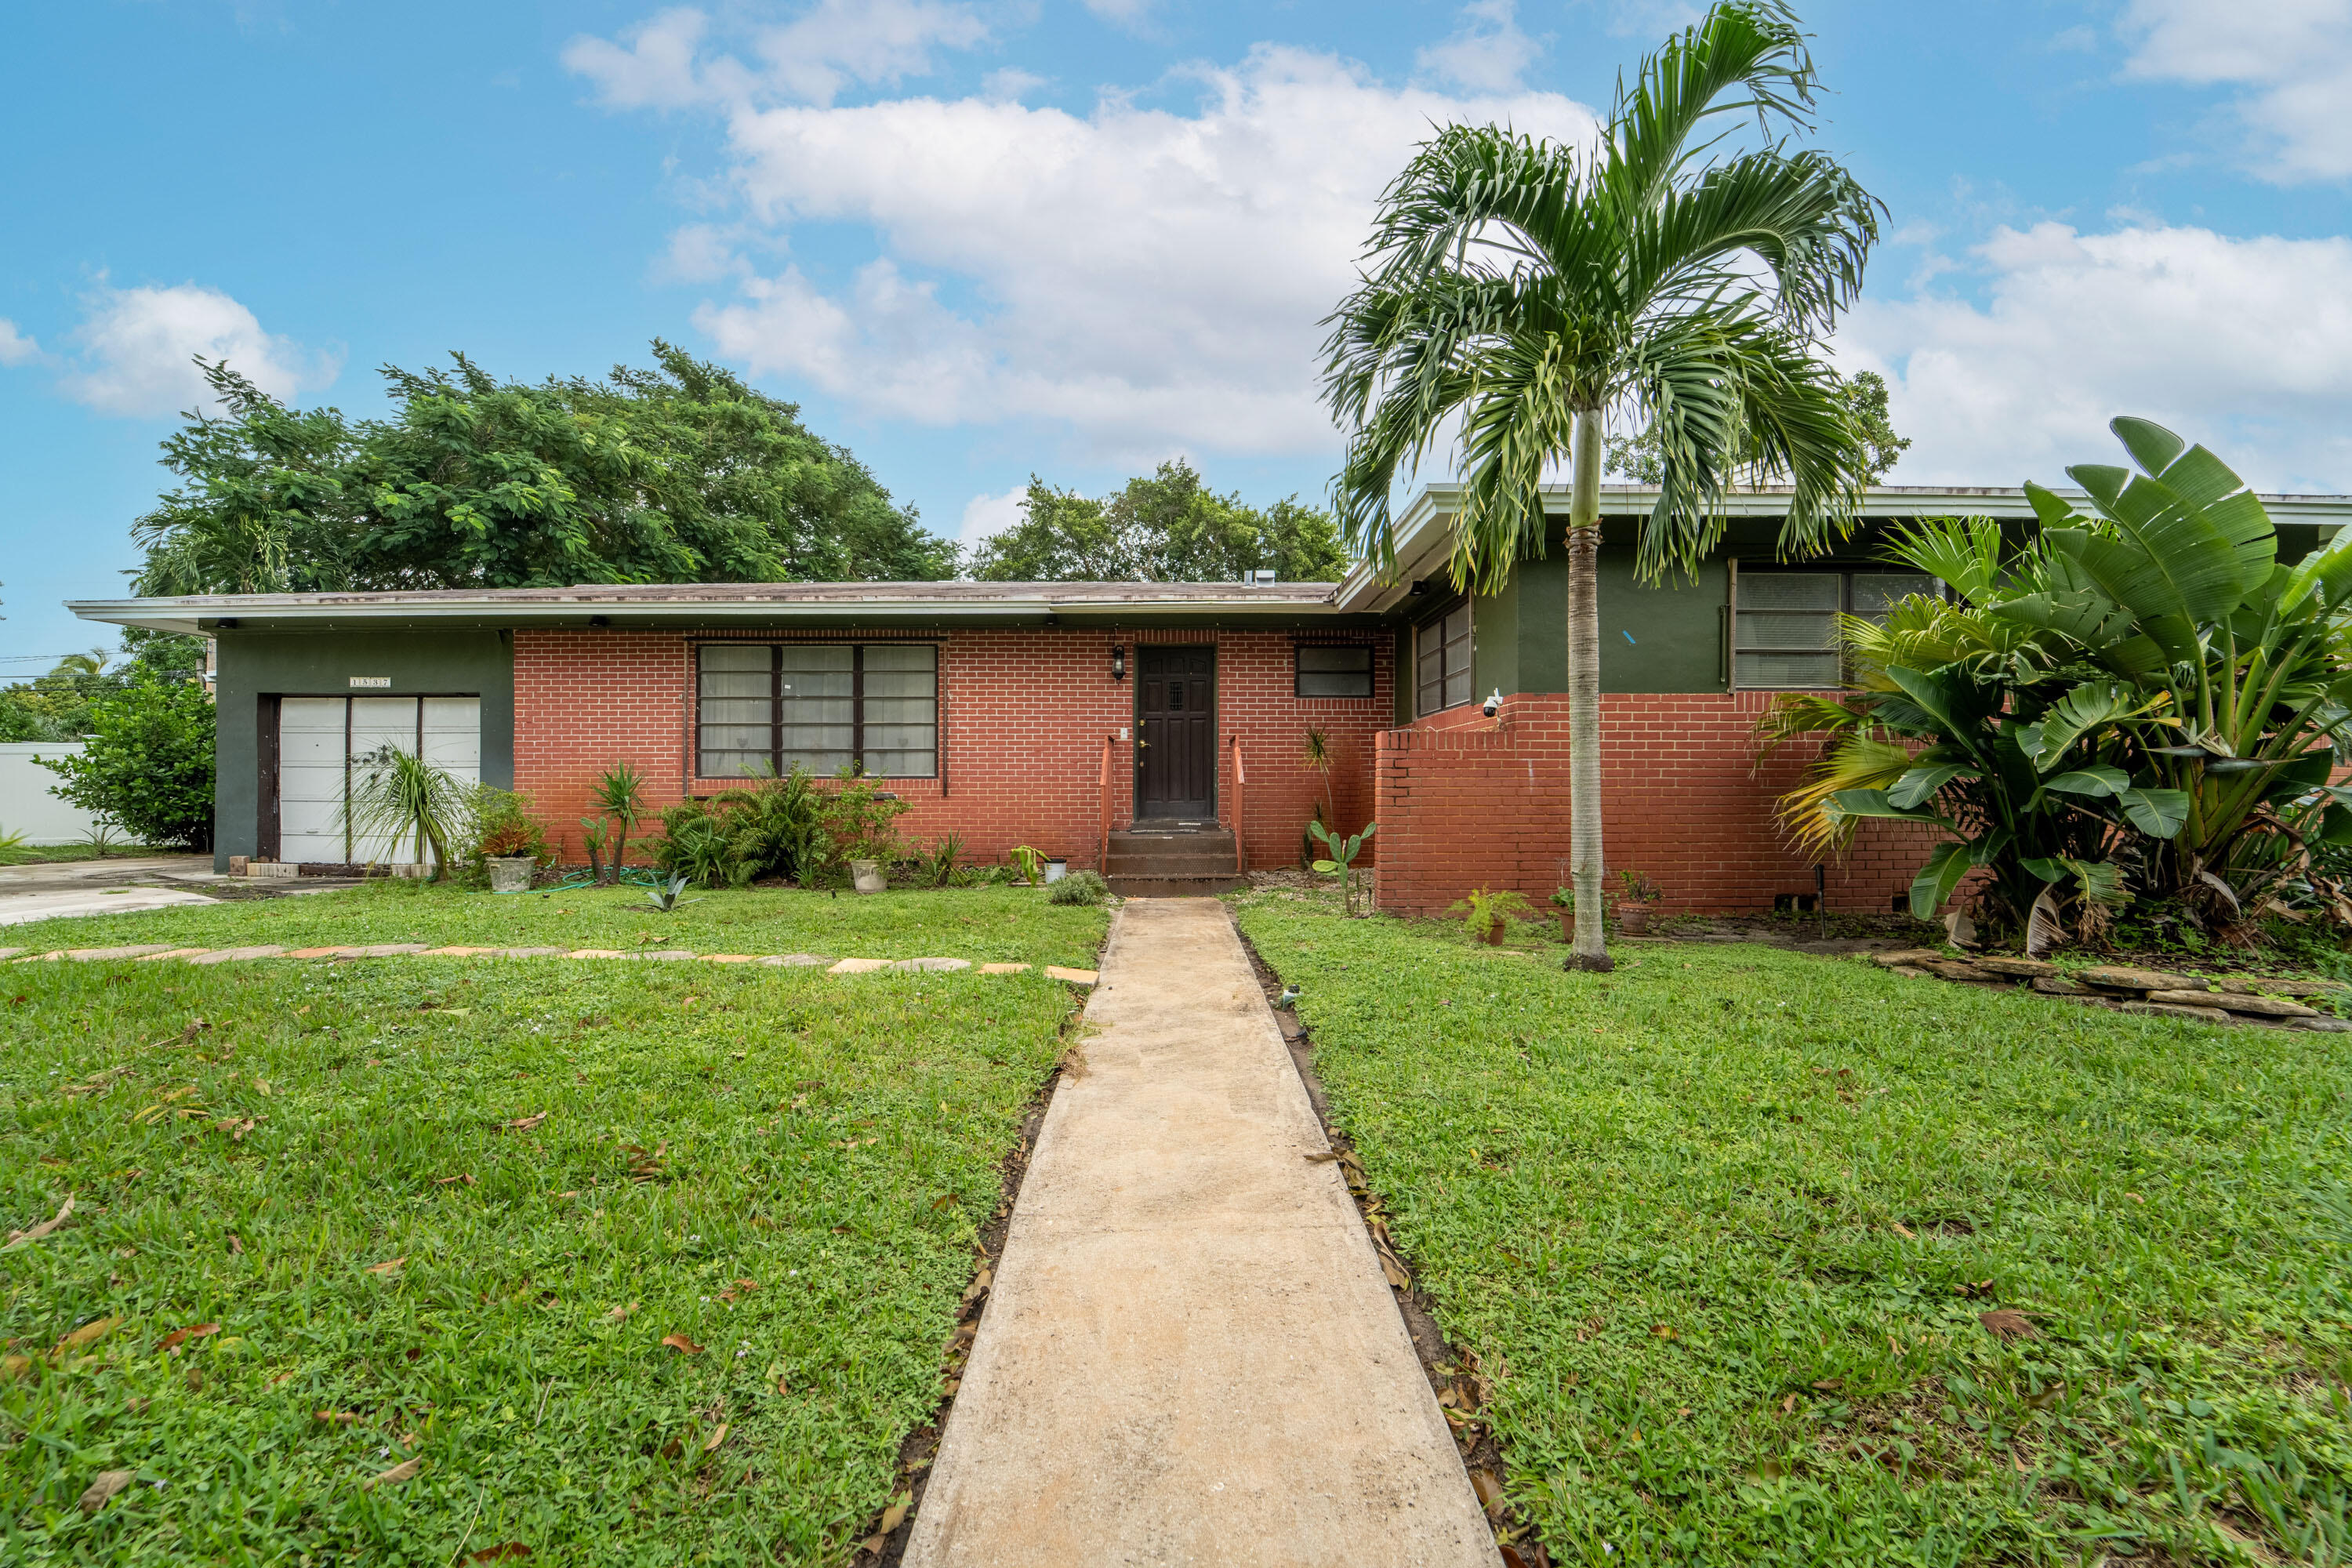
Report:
40,680,214,851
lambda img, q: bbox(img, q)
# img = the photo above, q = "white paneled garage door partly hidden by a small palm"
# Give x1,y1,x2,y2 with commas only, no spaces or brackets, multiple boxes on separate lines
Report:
278,696,482,865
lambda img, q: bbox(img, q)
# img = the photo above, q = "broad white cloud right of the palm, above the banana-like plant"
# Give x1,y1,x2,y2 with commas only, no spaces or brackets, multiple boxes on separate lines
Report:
1837,223,2352,492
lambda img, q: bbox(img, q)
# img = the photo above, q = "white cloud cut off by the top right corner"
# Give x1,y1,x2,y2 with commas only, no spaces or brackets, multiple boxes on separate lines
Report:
2119,0,2352,183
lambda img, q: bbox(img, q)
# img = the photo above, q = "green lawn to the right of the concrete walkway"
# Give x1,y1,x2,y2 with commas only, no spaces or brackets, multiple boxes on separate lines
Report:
1240,898,2352,1566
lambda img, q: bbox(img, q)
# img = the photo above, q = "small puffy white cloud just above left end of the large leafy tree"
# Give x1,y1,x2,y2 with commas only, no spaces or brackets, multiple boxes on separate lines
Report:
61,282,341,414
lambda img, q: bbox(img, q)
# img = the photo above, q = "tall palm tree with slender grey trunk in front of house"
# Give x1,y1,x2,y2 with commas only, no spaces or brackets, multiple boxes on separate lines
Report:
1324,0,1882,968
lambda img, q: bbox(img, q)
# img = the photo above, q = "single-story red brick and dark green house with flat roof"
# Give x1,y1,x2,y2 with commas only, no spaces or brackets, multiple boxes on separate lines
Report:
71,487,2352,912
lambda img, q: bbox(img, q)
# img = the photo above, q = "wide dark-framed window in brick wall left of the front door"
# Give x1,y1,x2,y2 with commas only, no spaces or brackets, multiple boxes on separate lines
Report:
694,642,938,779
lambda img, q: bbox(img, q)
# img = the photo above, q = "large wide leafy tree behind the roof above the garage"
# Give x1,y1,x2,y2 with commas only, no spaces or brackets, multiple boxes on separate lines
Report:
132,341,955,593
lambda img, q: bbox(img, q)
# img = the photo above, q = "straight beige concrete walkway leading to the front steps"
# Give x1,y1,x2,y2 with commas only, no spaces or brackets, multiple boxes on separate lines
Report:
906,898,1501,1568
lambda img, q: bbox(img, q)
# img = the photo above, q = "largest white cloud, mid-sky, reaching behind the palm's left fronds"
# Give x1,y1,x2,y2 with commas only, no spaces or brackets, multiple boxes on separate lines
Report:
654,47,1592,461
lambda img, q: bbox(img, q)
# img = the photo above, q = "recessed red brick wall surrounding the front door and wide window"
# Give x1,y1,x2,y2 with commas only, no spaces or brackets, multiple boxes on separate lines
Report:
515,628,1395,865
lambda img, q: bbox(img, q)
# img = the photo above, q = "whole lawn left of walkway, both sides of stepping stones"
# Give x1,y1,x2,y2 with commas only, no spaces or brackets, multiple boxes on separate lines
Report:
0,888,1103,1568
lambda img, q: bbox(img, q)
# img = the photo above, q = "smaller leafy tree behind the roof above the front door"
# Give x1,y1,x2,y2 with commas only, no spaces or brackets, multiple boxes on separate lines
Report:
971,459,1348,583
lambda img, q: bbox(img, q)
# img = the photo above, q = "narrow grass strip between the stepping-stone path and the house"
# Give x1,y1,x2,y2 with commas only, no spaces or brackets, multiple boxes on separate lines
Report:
0,879,1105,966
